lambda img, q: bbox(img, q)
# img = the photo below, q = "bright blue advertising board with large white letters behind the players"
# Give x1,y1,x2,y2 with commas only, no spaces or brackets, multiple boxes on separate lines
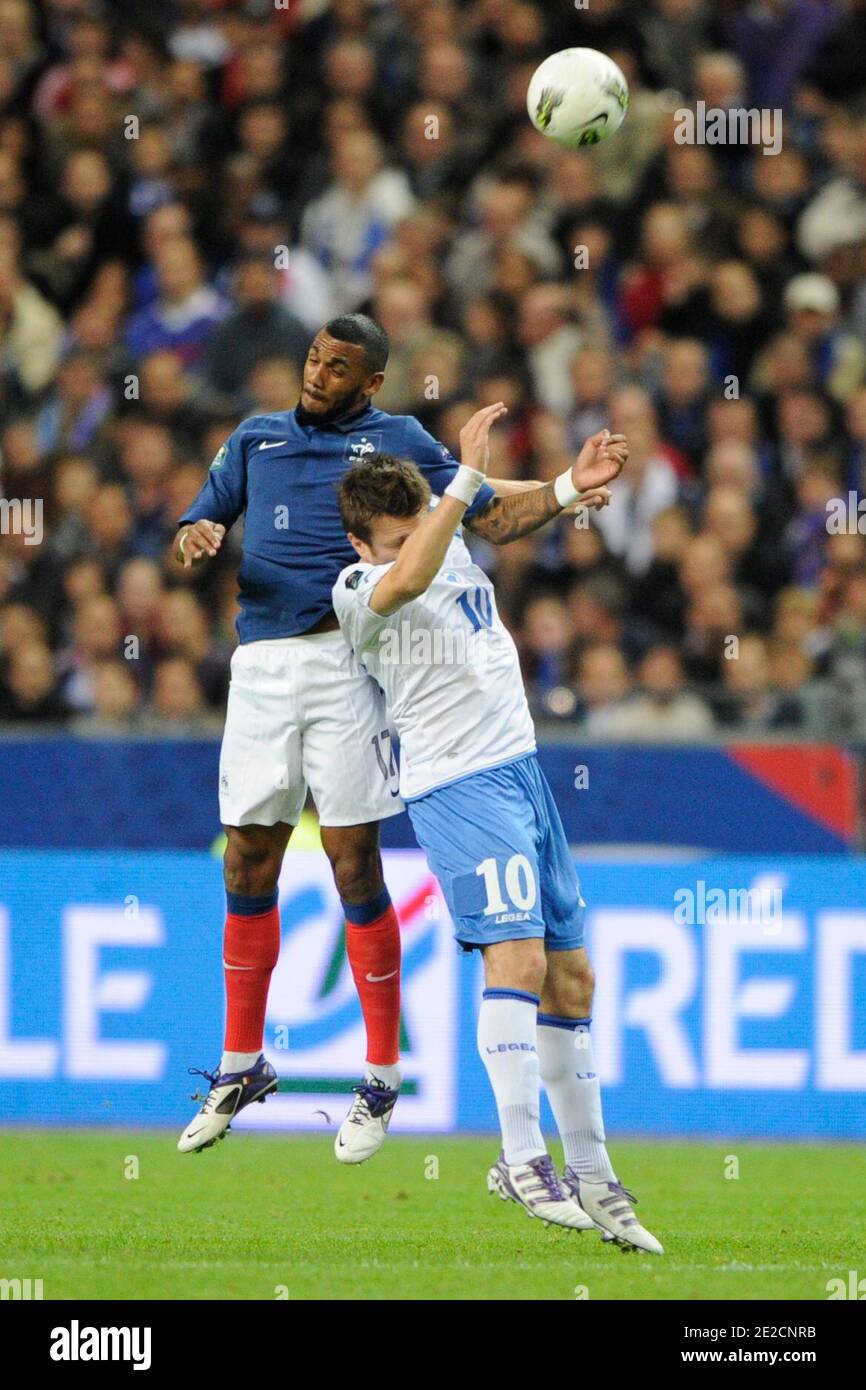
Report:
0,851,866,1140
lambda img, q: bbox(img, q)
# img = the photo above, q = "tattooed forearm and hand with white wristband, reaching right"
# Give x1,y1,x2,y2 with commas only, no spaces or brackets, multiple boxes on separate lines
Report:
466,430,628,545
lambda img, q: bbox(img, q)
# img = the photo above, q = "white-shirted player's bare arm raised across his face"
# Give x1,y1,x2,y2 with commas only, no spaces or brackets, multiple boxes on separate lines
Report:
370,400,507,616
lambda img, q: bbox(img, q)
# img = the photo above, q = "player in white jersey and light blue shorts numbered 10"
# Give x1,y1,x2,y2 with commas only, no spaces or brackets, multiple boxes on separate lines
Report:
334,403,662,1254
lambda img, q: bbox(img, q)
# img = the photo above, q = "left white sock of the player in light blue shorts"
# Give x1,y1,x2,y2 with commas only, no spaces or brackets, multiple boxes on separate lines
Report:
478,990,546,1163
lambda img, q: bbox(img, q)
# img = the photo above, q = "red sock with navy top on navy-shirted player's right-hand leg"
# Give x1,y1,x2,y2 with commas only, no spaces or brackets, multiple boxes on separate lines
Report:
343,890,400,1066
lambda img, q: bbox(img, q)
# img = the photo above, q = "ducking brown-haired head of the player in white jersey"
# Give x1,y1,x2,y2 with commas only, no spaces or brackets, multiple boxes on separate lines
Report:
339,453,430,564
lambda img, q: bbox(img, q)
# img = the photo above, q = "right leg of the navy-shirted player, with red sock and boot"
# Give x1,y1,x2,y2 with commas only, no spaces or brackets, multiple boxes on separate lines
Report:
321,823,402,1163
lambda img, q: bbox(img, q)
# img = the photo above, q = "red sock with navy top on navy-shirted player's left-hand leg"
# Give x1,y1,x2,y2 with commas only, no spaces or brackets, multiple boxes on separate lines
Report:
222,894,279,1052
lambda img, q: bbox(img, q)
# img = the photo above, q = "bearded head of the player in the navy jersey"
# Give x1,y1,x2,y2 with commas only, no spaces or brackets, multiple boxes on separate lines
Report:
300,314,388,424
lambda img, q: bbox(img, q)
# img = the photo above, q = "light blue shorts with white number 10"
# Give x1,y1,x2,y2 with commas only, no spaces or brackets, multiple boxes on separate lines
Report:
407,753,585,951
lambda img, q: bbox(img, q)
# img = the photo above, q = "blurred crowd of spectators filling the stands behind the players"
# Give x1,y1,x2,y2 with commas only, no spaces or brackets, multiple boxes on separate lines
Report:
0,0,866,739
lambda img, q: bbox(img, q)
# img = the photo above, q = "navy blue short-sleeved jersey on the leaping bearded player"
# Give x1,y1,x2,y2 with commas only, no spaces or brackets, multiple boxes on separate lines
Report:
178,406,495,642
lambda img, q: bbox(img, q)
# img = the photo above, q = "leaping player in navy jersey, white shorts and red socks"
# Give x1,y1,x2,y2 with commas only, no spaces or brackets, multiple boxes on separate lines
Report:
175,314,594,1162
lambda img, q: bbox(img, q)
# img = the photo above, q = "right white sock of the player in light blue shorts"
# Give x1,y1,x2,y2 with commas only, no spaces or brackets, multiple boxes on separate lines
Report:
538,1013,616,1182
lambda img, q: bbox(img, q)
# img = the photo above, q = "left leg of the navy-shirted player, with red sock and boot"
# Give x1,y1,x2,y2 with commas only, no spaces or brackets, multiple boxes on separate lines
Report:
178,823,292,1154
